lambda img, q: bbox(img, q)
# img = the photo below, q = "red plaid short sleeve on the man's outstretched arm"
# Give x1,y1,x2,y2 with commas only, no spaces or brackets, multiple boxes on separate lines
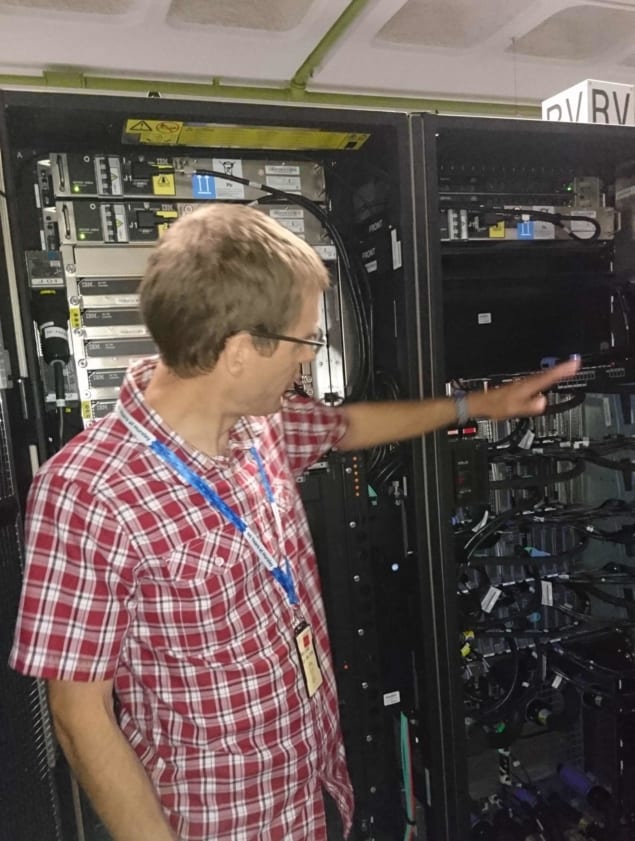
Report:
282,397,348,476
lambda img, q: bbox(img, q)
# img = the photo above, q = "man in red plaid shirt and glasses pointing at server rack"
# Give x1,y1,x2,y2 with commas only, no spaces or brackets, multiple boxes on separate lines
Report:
11,204,577,841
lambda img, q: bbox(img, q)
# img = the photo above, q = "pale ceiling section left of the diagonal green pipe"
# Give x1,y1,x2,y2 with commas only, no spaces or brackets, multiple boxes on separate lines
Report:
0,0,348,81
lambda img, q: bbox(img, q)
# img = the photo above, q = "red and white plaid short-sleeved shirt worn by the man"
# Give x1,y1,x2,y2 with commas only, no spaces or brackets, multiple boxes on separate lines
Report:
10,360,352,841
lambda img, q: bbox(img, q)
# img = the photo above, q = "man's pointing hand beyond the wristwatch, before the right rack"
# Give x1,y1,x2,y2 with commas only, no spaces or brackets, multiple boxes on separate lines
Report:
468,359,580,420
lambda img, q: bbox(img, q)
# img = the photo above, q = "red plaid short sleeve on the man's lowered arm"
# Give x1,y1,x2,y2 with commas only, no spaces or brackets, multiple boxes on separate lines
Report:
9,471,134,681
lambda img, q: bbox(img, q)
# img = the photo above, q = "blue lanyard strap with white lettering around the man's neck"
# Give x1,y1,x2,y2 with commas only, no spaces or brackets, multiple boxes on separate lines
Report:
117,404,300,607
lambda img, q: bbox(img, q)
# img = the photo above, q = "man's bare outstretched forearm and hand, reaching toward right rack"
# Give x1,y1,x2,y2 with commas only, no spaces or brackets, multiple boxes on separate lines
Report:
337,360,580,450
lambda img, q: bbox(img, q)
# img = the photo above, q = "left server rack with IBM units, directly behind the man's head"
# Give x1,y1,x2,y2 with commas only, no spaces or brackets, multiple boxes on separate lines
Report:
0,92,423,841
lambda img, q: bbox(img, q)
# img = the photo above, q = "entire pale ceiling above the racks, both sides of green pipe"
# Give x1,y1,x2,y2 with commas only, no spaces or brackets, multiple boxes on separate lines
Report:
0,0,635,104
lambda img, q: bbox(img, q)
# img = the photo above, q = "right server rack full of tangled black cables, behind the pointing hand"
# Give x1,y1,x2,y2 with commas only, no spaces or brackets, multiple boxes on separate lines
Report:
411,114,635,841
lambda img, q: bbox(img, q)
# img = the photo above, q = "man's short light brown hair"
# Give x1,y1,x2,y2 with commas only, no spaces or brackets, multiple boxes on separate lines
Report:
141,204,329,377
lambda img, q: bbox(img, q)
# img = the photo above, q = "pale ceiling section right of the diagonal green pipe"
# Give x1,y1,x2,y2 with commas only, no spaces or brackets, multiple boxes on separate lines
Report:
310,0,635,104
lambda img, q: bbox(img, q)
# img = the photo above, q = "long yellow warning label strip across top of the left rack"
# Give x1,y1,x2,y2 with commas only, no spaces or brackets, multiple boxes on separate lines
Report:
123,118,370,151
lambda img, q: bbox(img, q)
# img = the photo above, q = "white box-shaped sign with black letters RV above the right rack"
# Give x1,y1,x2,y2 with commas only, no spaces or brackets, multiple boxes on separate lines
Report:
542,79,635,126
